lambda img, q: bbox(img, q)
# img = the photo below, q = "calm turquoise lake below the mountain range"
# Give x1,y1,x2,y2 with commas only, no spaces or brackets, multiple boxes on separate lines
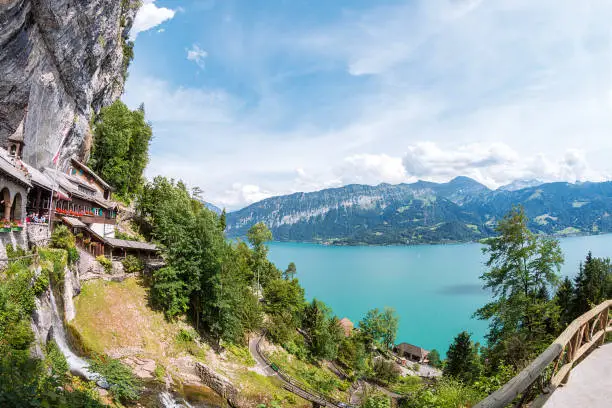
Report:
269,234,612,354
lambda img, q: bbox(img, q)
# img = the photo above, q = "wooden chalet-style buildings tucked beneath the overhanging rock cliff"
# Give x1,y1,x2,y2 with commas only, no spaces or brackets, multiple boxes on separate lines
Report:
0,115,158,260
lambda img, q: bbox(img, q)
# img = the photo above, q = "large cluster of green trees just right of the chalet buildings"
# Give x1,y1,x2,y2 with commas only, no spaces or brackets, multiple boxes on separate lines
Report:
137,177,262,344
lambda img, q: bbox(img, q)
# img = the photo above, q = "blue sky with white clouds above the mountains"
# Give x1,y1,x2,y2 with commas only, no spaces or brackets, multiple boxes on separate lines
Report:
124,0,612,209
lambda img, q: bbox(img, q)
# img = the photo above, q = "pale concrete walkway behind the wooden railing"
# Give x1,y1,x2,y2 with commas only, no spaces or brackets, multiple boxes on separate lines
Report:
544,343,612,408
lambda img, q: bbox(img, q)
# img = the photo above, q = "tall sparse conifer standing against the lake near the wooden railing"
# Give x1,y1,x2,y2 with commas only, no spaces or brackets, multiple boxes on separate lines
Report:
475,207,563,367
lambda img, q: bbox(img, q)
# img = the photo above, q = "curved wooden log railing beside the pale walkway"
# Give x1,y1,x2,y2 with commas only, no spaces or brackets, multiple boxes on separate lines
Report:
474,299,612,408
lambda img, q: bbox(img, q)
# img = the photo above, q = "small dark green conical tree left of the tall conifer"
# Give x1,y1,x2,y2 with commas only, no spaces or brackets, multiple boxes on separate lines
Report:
444,332,480,384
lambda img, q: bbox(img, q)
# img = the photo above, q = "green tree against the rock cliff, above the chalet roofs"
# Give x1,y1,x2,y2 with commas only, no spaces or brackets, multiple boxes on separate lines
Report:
89,100,152,200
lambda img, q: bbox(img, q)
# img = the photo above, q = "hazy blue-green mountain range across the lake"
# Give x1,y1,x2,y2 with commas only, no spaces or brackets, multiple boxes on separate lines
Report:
227,177,612,245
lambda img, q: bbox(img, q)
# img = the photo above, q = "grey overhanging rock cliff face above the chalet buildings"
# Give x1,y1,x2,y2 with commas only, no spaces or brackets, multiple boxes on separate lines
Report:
0,0,138,168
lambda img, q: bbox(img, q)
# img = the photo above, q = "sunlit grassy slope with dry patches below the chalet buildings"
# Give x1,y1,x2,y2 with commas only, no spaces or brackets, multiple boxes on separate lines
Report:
70,278,308,408
